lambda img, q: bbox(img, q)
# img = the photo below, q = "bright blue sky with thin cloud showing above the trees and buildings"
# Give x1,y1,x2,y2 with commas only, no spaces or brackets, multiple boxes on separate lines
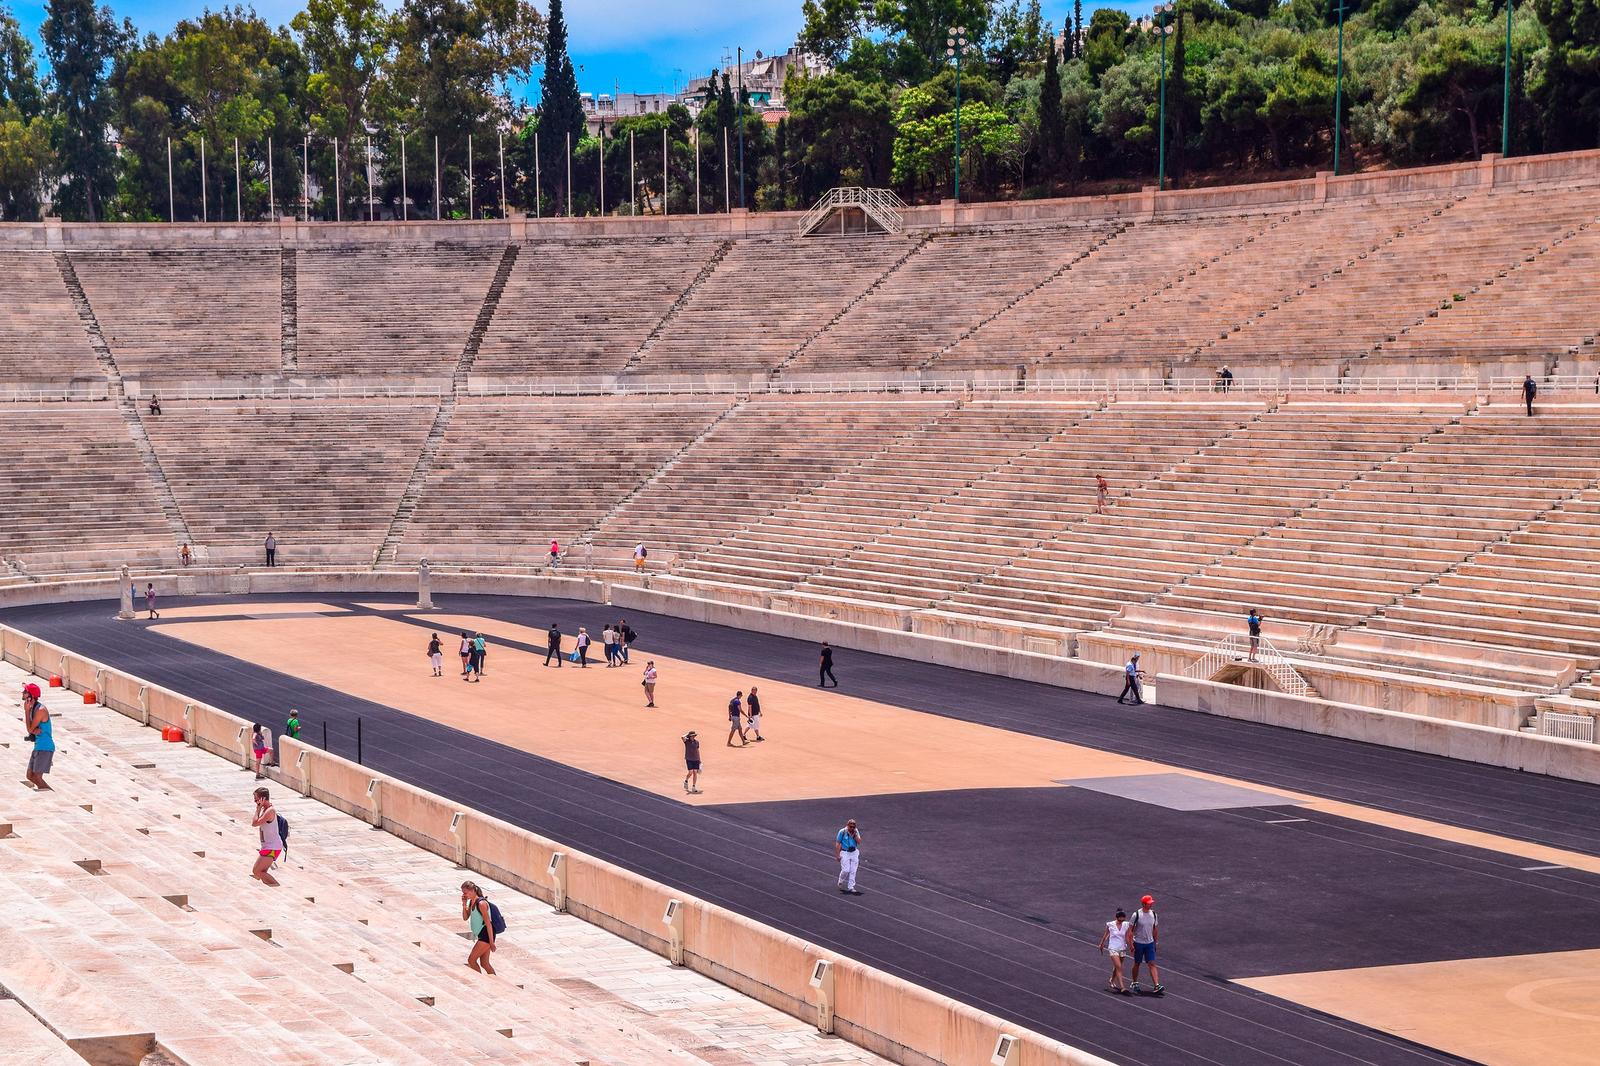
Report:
0,0,1150,93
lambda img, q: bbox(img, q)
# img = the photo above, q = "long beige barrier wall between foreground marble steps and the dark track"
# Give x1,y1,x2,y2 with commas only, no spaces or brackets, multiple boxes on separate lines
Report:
0,614,1110,1066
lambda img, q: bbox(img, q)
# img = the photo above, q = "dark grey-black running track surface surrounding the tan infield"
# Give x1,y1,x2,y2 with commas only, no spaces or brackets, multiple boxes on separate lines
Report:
0,595,1600,1066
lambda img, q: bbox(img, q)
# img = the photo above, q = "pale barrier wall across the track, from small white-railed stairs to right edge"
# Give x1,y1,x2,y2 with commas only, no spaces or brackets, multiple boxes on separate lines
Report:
1155,674,1600,784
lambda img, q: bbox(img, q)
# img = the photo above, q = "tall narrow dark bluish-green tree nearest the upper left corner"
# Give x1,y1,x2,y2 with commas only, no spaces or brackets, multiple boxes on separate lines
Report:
40,0,133,222
